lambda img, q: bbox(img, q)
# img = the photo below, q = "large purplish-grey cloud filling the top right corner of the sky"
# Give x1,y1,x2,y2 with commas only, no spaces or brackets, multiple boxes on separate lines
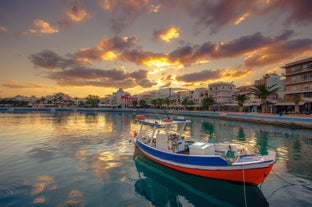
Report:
183,0,312,33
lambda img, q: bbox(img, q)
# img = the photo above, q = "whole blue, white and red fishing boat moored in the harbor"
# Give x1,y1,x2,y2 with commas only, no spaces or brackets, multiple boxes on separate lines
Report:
134,115,276,185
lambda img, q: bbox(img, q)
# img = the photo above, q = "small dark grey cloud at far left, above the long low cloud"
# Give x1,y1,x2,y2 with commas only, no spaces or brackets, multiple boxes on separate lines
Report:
30,50,76,69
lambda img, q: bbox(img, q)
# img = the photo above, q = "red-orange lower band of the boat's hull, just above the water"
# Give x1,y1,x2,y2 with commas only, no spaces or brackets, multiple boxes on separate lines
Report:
142,151,273,185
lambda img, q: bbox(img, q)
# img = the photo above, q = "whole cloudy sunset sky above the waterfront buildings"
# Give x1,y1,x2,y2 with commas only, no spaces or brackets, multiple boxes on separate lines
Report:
0,0,312,98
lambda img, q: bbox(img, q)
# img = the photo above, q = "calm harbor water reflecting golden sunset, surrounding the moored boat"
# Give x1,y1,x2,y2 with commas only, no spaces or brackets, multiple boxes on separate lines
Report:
0,112,312,207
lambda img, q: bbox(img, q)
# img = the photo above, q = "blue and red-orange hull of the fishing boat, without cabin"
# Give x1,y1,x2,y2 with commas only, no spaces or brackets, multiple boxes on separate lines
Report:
135,139,274,185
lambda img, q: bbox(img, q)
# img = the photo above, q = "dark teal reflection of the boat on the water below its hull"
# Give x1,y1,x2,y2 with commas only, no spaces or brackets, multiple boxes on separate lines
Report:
134,148,268,207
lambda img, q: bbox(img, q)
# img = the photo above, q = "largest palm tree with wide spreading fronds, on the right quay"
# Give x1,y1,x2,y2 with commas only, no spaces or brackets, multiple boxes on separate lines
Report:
250,83,279,113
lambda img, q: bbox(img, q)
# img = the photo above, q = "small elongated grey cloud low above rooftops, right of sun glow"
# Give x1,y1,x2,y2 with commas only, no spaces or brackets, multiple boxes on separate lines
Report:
176,70,220,82
